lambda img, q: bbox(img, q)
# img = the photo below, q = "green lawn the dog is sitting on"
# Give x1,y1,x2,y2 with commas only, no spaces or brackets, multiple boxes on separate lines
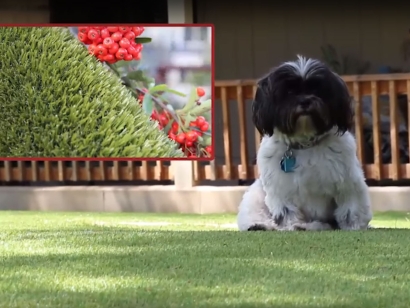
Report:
0,212,410,308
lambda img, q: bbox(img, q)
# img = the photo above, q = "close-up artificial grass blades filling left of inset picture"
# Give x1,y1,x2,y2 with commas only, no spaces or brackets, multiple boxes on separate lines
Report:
0,27,183,158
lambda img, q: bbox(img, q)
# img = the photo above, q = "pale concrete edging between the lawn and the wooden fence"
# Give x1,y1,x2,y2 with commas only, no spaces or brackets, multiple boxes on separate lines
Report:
0,185,410,214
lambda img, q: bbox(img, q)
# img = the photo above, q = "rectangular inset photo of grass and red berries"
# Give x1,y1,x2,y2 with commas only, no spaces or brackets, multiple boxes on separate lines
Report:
0,24,213,160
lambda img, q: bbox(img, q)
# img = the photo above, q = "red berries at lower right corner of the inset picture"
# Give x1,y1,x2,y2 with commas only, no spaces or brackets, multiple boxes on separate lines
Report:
138,87,212,158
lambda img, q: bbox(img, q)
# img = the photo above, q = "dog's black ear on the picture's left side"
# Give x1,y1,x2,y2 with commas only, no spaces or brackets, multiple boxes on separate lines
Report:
252,76,275,136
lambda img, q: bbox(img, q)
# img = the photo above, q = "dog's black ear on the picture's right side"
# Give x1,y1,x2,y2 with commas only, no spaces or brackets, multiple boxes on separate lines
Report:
332,75,354,134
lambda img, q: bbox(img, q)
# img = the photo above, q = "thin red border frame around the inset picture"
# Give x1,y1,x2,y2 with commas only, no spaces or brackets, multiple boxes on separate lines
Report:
0,23,215,161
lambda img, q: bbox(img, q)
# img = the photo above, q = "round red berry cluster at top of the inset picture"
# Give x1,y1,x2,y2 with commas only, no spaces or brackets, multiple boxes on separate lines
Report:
78,26,144,64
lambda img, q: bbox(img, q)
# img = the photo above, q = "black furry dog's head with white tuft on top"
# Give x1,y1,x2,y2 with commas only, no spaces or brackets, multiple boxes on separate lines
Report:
252,56,353,137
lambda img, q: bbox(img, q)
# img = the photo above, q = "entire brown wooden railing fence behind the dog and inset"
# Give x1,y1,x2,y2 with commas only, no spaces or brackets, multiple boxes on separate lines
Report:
0,74,410,183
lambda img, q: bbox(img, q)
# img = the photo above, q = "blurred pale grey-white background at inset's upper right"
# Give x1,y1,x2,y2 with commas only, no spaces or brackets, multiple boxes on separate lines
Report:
140,27,212,105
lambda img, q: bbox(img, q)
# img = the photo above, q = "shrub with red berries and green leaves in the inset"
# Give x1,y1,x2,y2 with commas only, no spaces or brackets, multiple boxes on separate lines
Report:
75,25,213,158
